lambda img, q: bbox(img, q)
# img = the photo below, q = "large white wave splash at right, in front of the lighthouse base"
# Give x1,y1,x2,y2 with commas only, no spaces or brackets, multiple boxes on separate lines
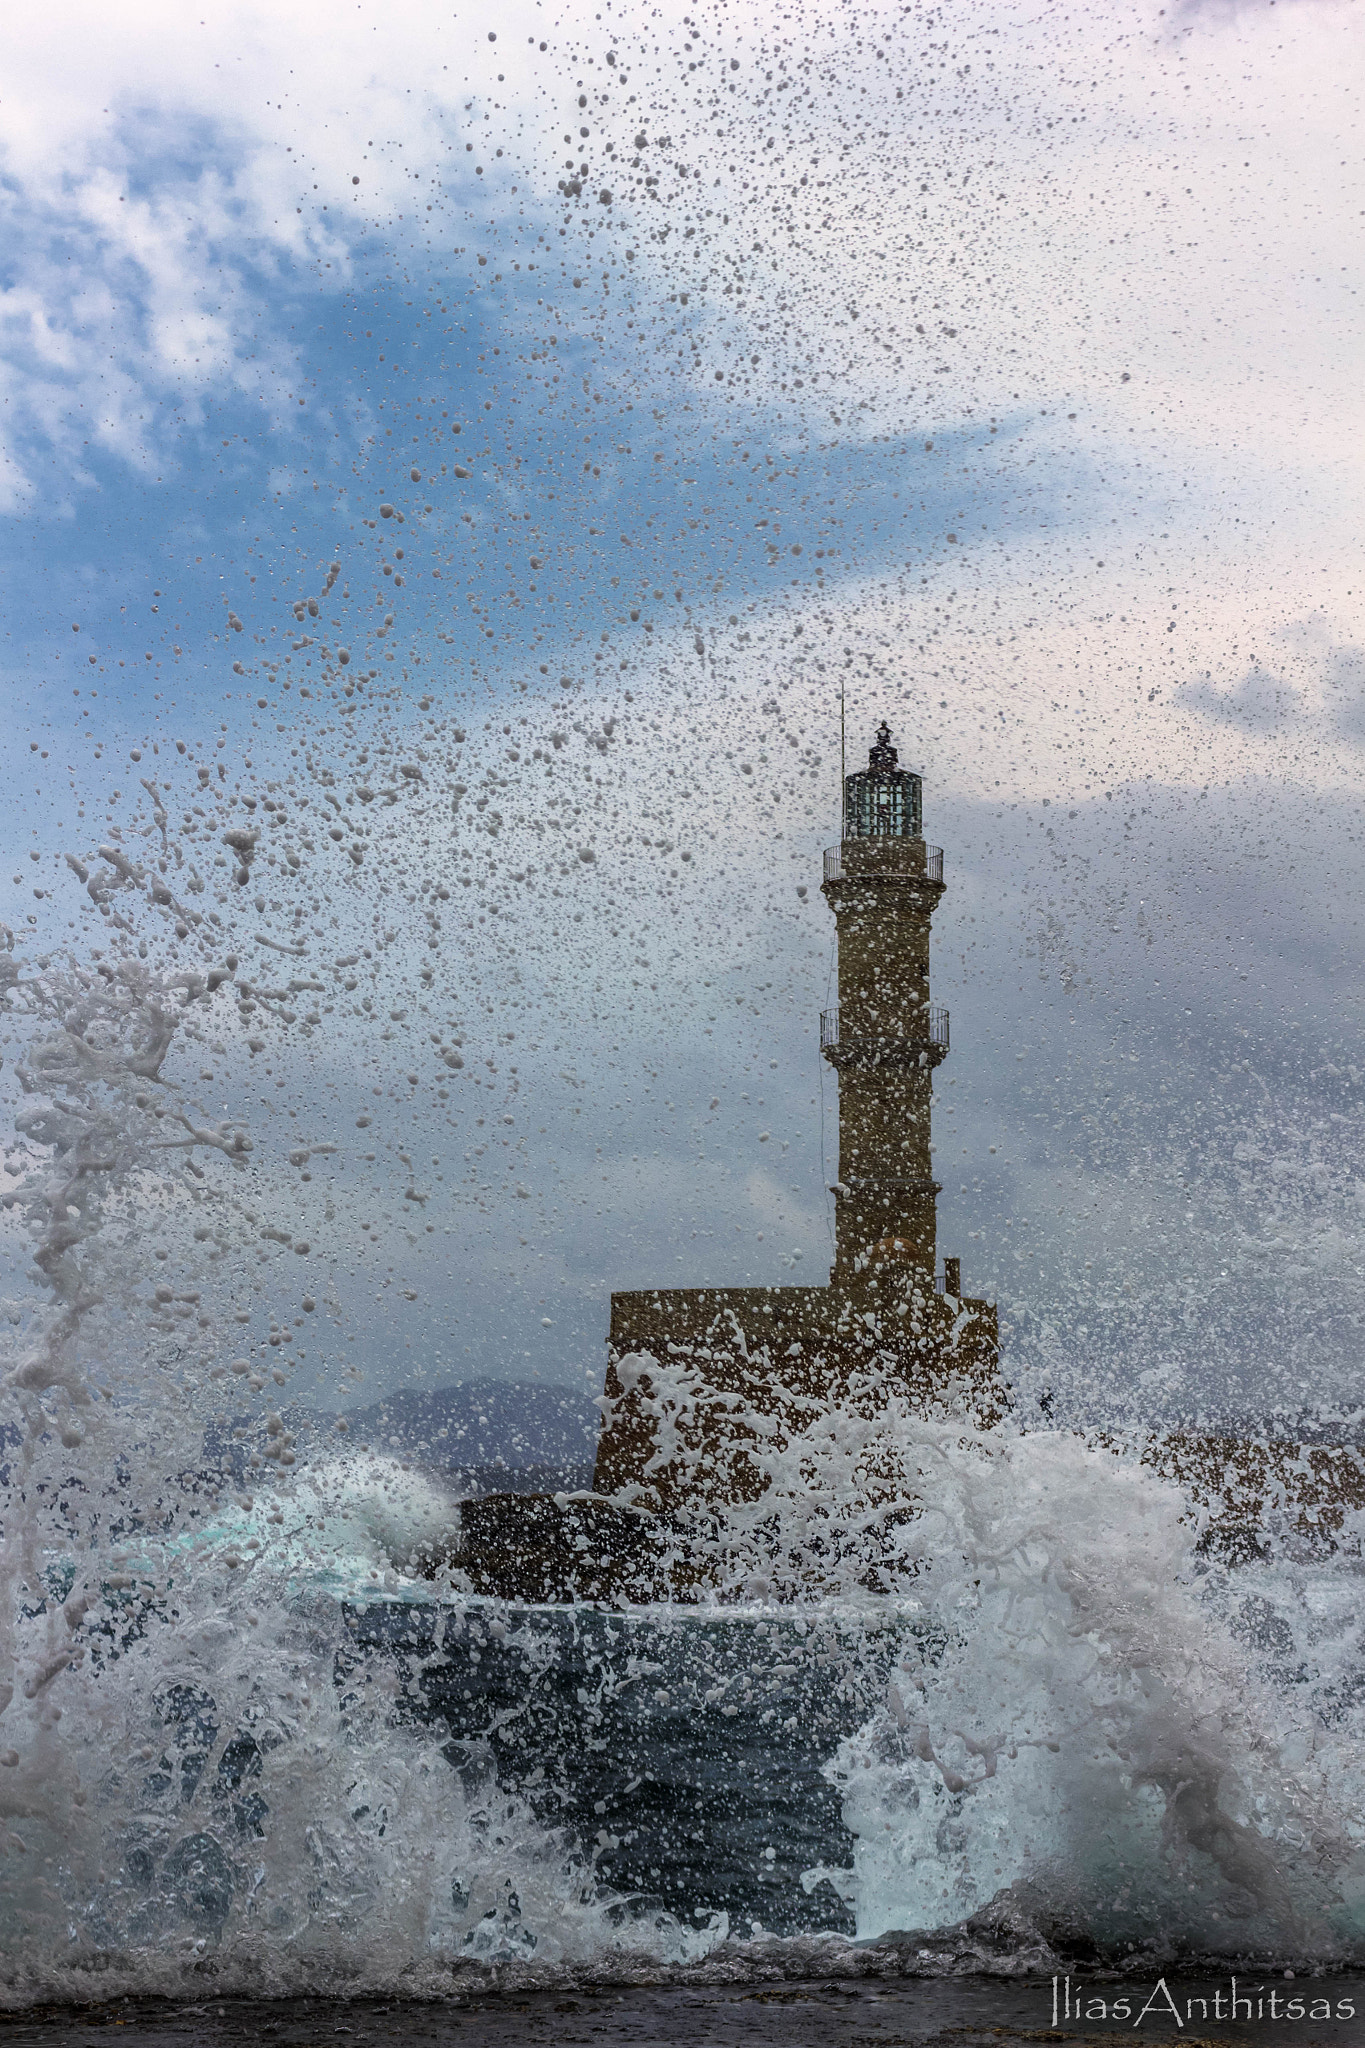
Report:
837,1436,1365,1956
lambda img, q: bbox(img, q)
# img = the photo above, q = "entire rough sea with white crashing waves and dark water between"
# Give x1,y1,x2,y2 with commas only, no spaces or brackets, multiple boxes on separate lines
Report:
0,1310,1365,2001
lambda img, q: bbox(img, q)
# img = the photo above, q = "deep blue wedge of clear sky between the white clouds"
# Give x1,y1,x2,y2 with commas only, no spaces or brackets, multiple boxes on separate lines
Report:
6,211,1064,753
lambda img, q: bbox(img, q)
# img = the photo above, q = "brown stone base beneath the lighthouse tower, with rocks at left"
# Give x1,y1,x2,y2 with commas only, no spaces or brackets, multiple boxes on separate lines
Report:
452,1262,1009,1604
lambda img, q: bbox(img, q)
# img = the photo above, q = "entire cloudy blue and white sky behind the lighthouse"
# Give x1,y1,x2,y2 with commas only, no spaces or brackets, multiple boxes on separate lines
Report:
0,0,1365,1417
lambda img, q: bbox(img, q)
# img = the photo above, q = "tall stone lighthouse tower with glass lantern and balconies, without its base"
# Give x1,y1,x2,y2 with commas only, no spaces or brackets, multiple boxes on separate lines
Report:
821,725,958,1294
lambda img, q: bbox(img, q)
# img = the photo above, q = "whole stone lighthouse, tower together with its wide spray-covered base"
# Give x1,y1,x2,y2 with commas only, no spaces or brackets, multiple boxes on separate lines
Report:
463,725,1009,1599
